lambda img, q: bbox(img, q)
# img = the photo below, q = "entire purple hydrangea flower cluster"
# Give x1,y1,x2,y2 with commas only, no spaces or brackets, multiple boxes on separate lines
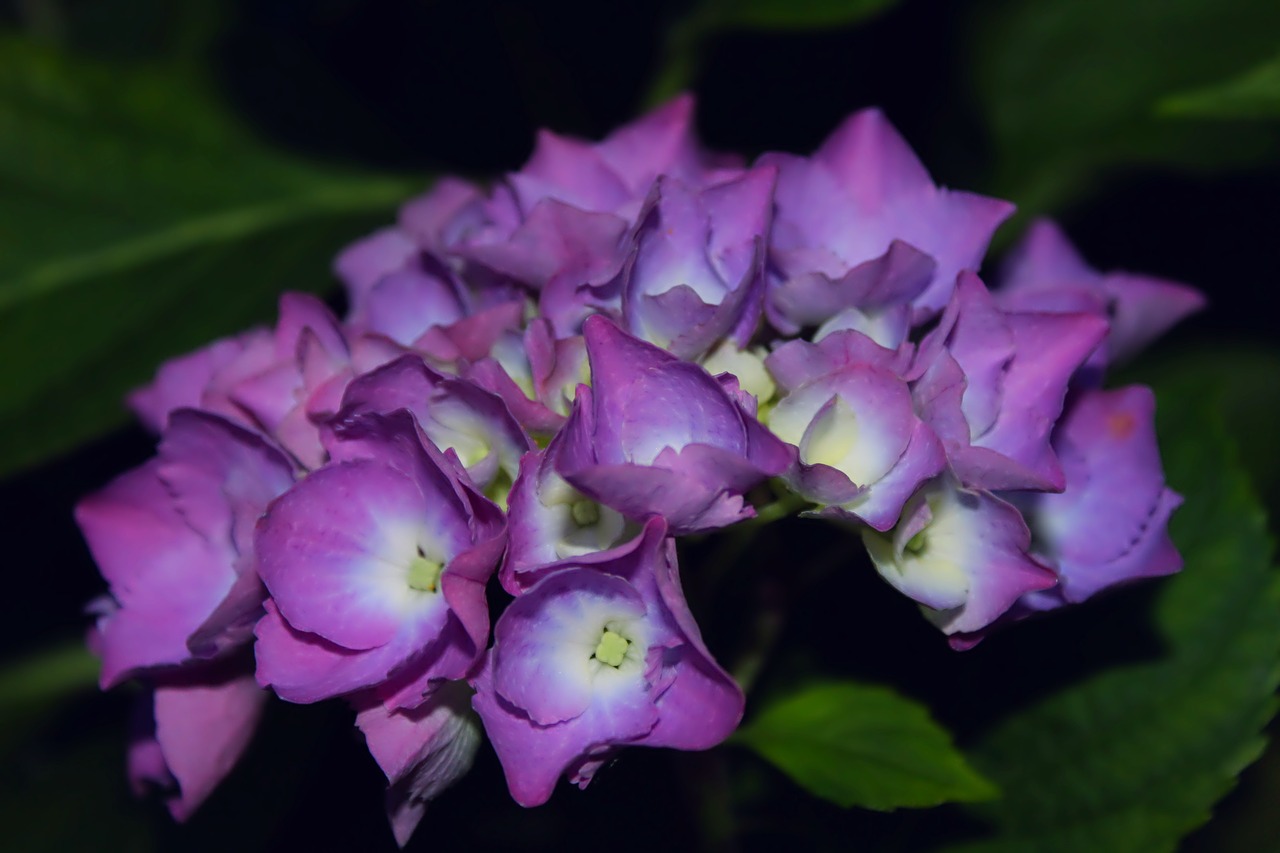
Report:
77,97,1201,843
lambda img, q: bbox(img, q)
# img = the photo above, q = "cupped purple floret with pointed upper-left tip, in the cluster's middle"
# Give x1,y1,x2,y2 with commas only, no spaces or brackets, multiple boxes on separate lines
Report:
554,315,792,534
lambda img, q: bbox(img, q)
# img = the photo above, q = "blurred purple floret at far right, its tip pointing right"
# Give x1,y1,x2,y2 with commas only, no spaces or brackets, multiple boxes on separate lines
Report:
996,219,1204,368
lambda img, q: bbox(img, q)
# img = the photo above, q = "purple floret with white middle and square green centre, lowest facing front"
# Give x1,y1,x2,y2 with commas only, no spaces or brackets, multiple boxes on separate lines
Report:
474,519,742,806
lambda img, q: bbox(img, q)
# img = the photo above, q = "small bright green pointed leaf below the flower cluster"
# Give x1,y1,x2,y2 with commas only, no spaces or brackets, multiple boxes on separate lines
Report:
733,681,996,811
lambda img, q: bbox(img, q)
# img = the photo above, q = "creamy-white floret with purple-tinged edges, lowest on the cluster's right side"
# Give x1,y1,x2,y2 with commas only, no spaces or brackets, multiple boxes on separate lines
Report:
863,478,1057,635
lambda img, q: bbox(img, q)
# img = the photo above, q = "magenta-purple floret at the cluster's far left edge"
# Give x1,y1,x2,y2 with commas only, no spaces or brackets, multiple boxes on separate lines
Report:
76,410,293,688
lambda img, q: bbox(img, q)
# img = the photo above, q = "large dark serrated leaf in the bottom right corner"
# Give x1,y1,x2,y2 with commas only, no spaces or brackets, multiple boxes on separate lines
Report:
957,382,1280,853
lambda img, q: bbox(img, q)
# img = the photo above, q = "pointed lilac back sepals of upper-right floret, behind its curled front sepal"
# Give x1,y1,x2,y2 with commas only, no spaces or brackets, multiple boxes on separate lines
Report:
759,109,1014,320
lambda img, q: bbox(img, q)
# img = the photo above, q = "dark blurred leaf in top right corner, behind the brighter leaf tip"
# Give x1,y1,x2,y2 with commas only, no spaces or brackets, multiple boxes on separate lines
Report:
966,0,1280,214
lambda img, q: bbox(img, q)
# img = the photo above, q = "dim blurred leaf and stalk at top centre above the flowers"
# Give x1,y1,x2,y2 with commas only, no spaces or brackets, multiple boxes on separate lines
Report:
644,0,899,106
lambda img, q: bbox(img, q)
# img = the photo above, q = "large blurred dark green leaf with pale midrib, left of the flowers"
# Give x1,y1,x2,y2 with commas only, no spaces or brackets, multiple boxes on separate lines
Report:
0,38,420,474
